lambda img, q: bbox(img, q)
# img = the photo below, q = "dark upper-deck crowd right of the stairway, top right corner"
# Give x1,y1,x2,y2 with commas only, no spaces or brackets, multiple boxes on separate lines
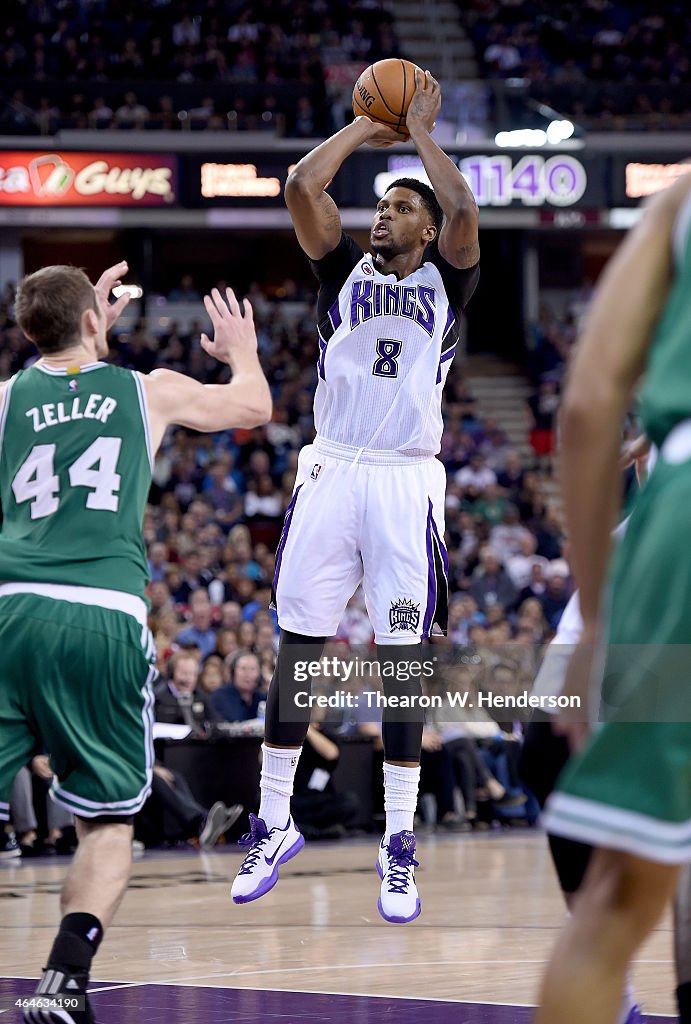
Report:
459,0,691,131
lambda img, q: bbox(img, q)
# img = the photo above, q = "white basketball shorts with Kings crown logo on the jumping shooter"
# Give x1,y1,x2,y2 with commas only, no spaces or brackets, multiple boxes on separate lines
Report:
273,438,448,644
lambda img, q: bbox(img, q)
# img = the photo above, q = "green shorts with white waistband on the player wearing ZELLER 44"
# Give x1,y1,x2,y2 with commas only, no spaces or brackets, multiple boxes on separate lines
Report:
0,588,157,820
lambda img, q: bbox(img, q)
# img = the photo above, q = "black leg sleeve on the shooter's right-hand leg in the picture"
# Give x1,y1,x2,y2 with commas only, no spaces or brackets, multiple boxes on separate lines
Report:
377,644,425,761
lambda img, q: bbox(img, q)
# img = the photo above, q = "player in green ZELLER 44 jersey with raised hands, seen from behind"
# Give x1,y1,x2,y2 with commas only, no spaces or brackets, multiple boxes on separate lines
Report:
0,263,271,1024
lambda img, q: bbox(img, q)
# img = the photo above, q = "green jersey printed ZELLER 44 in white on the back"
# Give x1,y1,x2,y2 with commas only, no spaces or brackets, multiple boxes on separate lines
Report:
0,362,153,597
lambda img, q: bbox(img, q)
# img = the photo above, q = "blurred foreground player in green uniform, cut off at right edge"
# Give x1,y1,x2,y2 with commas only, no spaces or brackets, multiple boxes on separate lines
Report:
535,177,691,1024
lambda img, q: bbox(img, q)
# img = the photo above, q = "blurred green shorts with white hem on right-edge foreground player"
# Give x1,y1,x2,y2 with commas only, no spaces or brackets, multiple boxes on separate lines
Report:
543,456,691,864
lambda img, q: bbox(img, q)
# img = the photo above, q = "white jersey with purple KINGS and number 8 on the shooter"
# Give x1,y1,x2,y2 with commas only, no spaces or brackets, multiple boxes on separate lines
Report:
311,234,479,456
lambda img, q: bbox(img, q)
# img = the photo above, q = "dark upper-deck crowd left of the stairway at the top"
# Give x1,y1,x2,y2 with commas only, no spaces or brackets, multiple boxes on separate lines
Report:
0,0,398,137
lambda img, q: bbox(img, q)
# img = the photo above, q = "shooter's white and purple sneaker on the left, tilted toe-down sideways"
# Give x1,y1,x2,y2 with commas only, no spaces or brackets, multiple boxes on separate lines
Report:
230,814,305,903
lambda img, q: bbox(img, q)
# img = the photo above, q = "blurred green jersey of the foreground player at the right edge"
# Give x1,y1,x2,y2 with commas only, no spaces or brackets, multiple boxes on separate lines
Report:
641,196,691,444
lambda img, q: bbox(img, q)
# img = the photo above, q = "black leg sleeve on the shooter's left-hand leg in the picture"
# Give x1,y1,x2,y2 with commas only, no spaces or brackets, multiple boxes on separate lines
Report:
264,630,327,746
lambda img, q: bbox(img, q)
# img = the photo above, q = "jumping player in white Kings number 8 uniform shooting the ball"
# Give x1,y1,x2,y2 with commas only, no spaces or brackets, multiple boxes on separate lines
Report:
231,69,479,923
